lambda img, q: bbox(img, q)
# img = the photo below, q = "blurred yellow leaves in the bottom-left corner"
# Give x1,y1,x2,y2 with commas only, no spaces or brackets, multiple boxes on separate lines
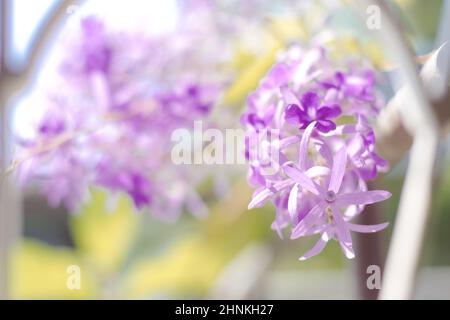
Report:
11,190,137,299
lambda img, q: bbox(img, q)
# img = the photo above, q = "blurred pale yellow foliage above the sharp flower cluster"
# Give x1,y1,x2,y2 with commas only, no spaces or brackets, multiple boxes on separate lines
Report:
223,2,406,106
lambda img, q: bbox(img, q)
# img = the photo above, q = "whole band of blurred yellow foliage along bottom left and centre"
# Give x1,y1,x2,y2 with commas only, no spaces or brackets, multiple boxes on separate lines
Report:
11,181,271,299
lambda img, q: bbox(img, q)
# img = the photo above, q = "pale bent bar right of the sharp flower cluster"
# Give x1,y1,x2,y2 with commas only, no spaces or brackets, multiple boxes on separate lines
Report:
365,0,450,299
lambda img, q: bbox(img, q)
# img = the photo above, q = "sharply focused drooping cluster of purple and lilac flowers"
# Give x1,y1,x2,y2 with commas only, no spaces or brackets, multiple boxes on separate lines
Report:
242,45,390,260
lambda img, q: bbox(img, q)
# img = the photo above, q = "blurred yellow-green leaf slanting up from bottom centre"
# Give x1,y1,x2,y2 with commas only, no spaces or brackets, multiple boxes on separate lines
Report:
123,179,273,298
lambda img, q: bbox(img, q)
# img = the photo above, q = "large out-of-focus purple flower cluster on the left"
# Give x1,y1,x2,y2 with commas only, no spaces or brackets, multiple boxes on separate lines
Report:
16,1,229,219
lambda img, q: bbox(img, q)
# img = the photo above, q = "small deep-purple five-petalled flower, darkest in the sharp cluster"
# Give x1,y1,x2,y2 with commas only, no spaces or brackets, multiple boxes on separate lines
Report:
284,91,342,133
